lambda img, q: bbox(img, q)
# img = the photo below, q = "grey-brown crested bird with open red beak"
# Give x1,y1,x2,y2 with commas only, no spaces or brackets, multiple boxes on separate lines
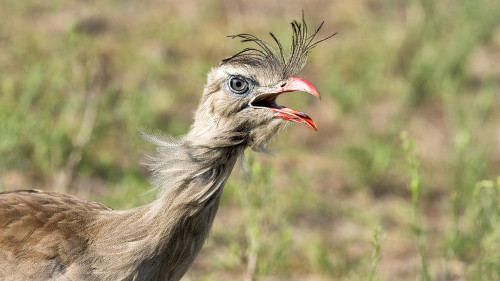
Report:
0,15,335,281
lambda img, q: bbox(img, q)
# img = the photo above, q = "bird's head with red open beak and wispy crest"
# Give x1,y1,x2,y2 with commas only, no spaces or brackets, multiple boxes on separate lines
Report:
194,18,335,148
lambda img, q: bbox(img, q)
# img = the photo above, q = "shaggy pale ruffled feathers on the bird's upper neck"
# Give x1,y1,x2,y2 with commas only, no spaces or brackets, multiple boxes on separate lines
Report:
143,124,245,199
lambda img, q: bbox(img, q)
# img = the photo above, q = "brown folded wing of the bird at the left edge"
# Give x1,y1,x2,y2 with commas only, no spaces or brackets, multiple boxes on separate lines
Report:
0,190,111,280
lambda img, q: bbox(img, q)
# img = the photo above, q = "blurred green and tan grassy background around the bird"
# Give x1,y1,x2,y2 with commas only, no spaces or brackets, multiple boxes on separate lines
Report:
0,0,500,281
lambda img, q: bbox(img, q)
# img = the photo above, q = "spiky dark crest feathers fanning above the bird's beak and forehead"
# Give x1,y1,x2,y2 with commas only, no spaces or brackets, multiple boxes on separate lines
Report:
221,14,337,79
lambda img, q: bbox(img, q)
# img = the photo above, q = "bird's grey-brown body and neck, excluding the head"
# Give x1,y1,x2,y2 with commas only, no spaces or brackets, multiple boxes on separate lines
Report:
0,135,241,281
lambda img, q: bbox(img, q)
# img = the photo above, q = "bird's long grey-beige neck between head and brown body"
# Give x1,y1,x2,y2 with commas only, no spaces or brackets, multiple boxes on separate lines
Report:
92,131,245,280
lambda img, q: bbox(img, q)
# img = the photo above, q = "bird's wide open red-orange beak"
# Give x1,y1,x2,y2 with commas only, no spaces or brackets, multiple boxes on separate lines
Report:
250,76,321,131
